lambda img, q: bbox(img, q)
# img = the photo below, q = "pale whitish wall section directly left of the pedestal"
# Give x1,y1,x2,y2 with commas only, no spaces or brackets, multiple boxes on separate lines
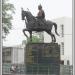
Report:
12,47,24,64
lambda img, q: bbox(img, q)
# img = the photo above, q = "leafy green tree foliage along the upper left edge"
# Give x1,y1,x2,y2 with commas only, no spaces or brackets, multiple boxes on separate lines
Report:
2,0,15,38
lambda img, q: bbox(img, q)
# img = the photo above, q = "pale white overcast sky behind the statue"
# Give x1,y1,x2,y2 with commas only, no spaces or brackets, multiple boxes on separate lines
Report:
3,0,72,64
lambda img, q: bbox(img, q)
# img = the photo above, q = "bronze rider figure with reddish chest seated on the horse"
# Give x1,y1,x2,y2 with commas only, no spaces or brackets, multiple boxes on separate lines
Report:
36,4,46,25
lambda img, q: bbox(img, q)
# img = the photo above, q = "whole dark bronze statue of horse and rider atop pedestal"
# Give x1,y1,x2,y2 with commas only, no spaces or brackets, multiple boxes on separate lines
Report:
21,5,59,42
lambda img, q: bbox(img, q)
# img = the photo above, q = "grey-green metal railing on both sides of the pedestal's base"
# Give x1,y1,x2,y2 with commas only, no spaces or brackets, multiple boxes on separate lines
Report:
2,63,73,75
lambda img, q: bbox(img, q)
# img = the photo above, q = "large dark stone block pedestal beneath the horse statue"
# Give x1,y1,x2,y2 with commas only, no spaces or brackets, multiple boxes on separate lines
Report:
25,43,60,75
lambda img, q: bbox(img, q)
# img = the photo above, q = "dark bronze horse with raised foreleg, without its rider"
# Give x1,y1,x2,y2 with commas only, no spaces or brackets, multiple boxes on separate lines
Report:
21,9,59,42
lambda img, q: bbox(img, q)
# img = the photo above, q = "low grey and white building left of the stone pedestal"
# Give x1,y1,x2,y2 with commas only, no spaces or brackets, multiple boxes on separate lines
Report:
2,46,24,64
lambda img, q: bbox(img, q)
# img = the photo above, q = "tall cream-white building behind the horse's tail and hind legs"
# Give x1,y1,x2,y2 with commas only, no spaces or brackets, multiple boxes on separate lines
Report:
44,17,72,64
